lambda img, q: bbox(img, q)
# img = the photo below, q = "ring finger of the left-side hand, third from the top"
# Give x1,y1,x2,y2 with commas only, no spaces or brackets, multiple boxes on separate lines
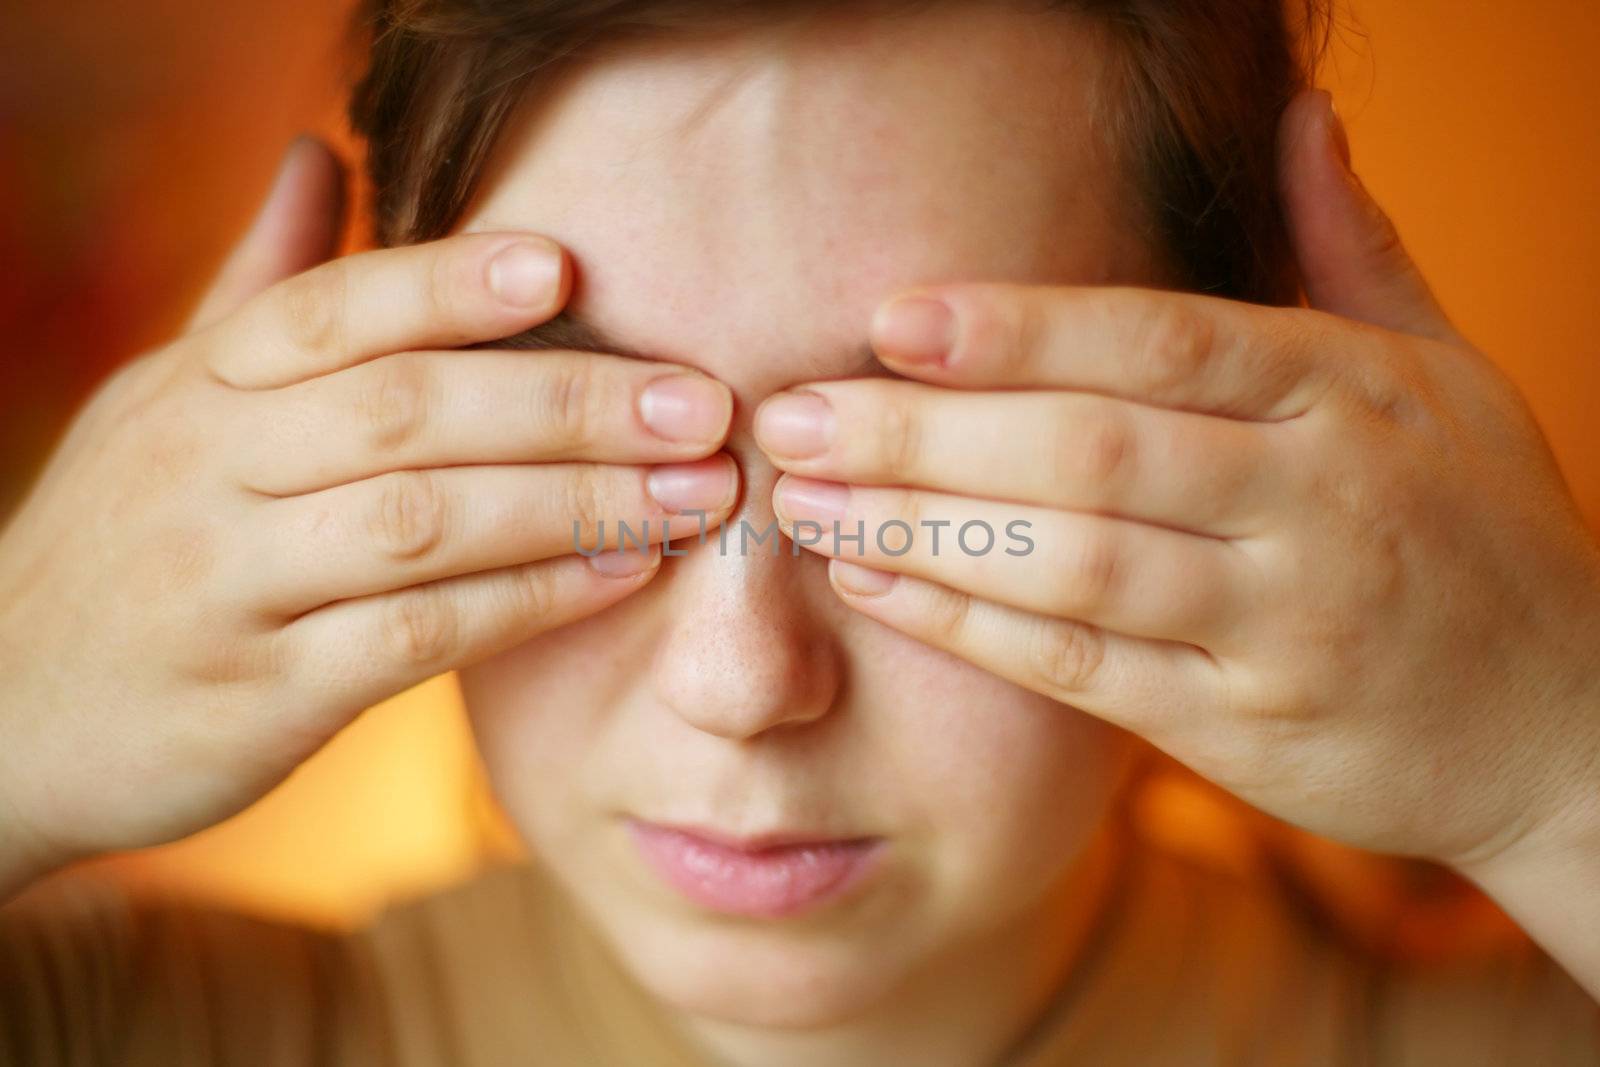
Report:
250,456,738,616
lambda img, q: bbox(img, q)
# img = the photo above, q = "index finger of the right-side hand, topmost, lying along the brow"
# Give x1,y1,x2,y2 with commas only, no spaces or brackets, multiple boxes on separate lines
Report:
872,285,1376,422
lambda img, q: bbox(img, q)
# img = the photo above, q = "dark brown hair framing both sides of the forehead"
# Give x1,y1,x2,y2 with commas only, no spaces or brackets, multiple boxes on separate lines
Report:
350,0,1328,304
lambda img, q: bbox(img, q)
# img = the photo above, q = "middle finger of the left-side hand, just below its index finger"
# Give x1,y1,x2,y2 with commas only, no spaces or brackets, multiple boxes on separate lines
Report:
232,350,733,496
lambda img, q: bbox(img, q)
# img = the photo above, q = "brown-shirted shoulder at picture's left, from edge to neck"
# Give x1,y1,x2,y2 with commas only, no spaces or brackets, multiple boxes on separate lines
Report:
0,865,696,1067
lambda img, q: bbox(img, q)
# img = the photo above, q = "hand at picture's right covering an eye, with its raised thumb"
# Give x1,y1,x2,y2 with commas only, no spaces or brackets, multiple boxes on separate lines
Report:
757,93,1600,902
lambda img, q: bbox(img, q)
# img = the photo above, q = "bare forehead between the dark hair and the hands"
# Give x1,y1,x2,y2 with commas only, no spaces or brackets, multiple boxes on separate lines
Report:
462,3,1144,394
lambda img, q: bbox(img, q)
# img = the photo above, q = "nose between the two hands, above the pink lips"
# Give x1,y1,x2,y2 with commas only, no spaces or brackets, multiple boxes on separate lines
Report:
653,445,842,741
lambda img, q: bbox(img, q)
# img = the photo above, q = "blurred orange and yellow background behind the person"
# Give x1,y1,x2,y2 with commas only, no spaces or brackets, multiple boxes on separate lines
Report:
0,0,1600,950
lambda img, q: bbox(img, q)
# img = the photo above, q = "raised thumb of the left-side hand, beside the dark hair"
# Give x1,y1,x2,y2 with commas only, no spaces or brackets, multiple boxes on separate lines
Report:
186,136,344,333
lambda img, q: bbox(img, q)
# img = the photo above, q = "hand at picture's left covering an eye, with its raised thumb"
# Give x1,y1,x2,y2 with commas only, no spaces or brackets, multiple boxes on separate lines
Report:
0,142,738,897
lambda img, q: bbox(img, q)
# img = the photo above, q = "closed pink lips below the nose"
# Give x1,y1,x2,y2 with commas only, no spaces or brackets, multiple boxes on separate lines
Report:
627,819,883,918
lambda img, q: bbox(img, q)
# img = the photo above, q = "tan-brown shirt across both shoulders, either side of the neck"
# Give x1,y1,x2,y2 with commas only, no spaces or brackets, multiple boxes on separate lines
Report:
0,846,1600,1067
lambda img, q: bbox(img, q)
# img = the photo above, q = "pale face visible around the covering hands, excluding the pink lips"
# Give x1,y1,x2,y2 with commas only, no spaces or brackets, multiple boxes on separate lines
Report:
462,3,1150,1025
